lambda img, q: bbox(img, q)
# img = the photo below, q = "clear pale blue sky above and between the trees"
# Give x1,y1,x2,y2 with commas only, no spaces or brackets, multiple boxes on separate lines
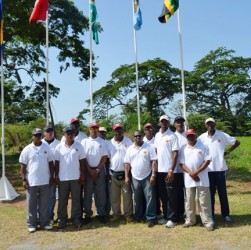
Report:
49,0,251,124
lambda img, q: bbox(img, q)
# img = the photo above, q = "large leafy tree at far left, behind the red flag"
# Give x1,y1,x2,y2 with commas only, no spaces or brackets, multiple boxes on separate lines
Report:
3,0,99,122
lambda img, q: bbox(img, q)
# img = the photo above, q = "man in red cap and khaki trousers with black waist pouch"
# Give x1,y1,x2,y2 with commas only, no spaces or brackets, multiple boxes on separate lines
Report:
110,123,133,222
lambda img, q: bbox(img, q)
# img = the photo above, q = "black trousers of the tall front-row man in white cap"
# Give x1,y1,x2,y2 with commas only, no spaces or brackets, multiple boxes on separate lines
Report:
157,173,178,222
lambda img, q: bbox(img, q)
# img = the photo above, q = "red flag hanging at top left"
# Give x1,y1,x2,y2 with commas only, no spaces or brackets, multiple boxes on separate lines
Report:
29,0,49,22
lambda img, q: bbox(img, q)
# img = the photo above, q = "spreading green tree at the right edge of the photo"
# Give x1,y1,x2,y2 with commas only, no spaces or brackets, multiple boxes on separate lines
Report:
186,47,251,133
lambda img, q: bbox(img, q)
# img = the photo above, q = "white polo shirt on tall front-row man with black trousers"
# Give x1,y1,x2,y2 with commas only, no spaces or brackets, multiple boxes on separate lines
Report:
154,128,179,173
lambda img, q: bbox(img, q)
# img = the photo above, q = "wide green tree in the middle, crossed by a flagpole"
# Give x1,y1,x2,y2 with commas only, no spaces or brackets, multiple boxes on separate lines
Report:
89,58,181,119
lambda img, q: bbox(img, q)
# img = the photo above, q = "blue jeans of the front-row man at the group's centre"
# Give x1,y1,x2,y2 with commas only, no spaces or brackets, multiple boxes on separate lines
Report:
132,175,156,221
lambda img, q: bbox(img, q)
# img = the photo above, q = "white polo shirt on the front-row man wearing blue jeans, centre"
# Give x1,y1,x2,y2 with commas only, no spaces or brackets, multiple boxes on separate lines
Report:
124,142,157,180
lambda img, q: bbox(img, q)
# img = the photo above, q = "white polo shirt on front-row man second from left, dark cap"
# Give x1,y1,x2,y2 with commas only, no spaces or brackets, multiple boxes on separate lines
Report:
55,141,86,181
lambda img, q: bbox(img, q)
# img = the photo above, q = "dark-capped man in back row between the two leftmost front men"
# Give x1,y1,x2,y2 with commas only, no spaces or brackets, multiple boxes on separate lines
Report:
42,125,60,224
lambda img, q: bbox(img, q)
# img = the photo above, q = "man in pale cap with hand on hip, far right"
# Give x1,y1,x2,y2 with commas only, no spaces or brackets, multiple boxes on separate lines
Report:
198,118,240,222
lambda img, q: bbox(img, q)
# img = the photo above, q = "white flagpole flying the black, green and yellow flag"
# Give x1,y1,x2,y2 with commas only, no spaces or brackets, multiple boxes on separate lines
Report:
177,8,186,129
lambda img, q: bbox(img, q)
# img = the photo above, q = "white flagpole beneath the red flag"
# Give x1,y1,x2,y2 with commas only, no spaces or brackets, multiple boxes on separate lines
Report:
46,10,50,125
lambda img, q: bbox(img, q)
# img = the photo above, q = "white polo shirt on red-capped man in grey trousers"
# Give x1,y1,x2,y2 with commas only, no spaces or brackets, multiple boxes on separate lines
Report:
81,136,108,168
